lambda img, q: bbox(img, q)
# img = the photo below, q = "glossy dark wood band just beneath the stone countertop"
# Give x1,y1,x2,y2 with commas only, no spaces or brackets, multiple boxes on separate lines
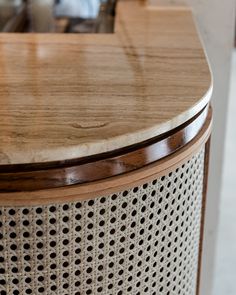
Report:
0,106,209,193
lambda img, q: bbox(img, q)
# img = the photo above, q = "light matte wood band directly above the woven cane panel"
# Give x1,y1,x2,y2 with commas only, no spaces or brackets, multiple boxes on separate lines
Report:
0,108,212,206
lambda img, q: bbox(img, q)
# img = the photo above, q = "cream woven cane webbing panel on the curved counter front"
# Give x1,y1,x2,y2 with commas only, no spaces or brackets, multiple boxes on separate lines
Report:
0,151,204,295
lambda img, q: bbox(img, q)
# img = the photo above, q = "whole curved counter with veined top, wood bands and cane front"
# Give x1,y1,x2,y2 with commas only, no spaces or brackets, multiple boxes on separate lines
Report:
0,0,212,295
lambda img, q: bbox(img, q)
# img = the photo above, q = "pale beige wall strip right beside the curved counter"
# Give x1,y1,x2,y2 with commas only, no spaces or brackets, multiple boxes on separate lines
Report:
189,0,235,295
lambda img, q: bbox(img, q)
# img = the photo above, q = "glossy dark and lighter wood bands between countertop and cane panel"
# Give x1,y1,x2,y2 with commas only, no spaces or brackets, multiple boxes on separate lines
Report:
0,106,212,206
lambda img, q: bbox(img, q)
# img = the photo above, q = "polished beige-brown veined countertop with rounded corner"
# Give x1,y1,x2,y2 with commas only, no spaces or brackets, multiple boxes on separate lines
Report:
0,0,212,165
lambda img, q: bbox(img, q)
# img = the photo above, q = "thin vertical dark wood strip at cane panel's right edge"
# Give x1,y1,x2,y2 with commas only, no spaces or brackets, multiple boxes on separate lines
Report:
196,137,211,295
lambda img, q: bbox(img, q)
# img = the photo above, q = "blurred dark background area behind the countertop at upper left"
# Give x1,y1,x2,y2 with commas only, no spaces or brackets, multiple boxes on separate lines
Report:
0,0,116,33
